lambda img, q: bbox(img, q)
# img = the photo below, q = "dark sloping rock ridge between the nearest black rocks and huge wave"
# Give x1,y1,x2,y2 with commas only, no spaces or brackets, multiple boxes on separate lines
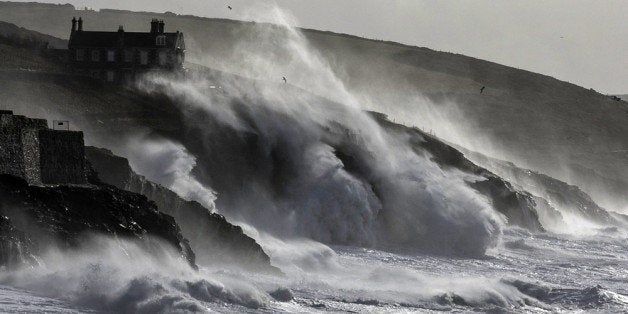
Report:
86,147,278,272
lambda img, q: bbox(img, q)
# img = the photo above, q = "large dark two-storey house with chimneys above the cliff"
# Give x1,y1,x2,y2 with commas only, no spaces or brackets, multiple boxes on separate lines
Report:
68,17,185,82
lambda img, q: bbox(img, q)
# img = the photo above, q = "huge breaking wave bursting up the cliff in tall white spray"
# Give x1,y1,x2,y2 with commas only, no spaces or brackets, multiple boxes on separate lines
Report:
138,3,501,256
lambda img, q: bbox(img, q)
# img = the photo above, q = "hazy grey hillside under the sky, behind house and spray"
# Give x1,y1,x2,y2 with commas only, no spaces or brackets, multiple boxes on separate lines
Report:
0,3,628,210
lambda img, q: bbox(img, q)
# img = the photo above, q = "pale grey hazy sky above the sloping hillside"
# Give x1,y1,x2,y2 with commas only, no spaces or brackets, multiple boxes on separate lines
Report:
14,0,628,94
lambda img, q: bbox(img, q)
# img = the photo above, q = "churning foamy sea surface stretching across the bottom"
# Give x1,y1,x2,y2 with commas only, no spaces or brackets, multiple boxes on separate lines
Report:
0,230,628,313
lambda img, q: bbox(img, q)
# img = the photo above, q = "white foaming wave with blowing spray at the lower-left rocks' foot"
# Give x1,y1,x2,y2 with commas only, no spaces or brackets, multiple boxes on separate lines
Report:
0,237,271,313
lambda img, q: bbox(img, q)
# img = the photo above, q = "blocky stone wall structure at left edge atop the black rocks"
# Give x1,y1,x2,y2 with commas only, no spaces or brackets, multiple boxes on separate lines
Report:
0,110,87,184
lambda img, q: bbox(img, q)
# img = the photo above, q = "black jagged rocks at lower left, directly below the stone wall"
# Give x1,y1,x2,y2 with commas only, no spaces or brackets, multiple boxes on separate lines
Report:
0,175,196,267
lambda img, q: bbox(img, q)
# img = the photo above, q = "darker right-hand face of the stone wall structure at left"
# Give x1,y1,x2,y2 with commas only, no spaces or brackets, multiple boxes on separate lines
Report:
39,129,87,184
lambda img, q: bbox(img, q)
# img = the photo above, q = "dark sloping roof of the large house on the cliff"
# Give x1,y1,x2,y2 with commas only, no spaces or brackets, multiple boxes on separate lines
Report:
69,31,185,49
